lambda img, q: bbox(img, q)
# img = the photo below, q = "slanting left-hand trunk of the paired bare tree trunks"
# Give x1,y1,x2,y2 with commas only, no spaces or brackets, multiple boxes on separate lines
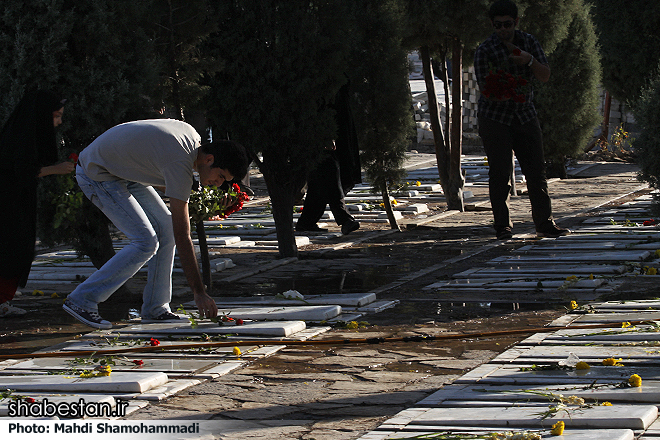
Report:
419,46,449,194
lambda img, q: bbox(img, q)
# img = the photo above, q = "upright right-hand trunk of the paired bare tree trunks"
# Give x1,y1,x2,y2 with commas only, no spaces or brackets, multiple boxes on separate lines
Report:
445,38,465,212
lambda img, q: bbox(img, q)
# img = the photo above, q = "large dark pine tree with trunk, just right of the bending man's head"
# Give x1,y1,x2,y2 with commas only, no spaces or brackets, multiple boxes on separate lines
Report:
207,0,349,257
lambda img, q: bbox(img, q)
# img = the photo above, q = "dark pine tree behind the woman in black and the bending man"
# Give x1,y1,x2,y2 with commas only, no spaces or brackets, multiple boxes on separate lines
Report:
0,0,160,267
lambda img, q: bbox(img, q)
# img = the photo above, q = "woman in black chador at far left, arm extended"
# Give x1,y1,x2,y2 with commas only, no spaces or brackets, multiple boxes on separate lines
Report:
0,90,74,318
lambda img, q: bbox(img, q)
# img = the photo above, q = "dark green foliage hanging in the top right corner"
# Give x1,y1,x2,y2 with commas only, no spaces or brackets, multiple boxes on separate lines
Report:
591,0,660,102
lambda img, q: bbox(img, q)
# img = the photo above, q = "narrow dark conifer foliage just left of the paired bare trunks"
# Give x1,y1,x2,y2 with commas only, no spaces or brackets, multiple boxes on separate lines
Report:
351,0,414,188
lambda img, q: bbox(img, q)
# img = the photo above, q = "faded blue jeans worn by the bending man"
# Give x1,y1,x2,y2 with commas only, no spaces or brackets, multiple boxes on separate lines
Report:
68,166,175,318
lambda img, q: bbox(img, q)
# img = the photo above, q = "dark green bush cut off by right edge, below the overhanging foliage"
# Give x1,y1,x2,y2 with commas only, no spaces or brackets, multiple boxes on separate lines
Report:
633,74,660,189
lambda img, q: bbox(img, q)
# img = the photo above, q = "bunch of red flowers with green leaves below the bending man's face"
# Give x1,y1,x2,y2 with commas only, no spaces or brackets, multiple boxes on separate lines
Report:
188,183,250,223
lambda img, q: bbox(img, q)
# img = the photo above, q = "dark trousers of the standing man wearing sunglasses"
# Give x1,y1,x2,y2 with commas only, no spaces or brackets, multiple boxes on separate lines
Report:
479,118,554,232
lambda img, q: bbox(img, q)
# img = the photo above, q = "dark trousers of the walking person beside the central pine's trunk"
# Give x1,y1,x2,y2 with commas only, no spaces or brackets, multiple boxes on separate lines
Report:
297,153,353,226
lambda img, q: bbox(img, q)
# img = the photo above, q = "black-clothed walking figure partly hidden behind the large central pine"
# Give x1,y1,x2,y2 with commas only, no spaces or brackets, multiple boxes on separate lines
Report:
296,84,362,234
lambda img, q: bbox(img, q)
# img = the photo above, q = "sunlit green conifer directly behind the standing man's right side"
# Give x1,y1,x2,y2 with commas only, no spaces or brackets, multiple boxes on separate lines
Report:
534,5,602,163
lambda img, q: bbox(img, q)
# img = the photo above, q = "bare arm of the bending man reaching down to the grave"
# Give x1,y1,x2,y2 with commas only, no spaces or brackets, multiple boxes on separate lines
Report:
170,198,218,318
